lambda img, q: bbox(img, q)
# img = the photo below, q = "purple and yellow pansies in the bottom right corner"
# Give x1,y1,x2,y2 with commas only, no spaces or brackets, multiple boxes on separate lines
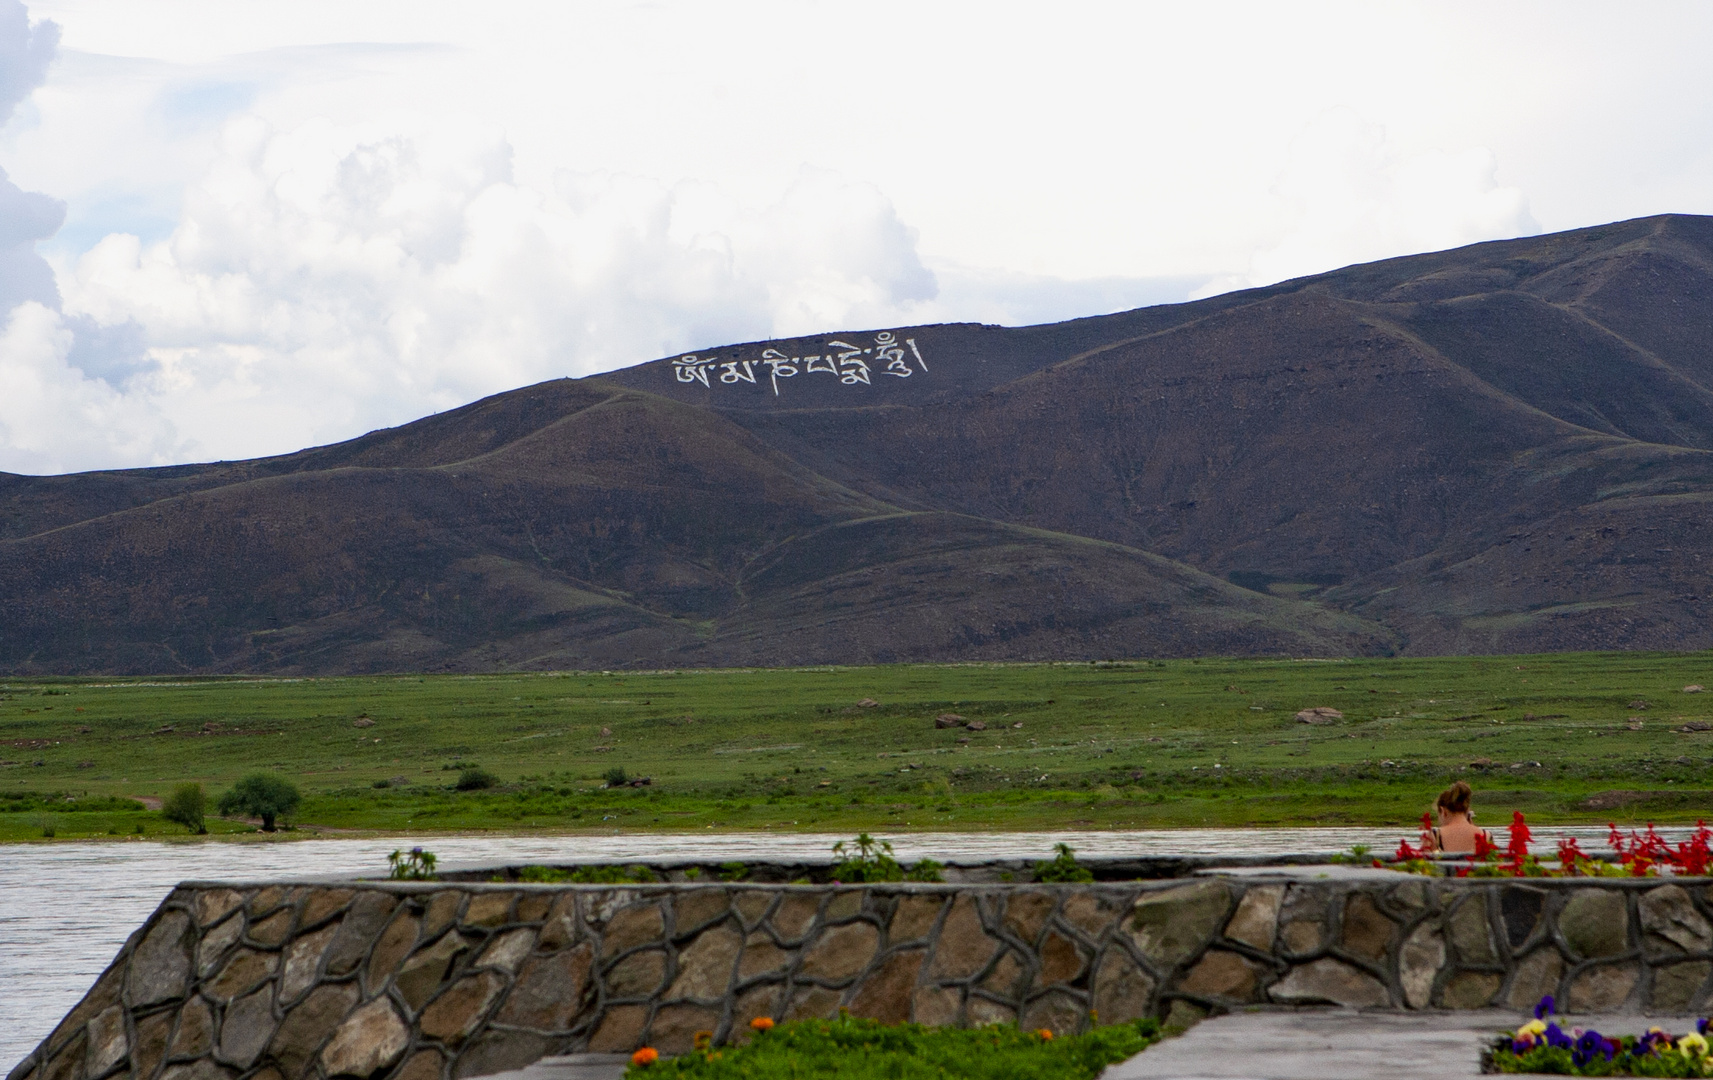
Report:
1485,996,1713,1077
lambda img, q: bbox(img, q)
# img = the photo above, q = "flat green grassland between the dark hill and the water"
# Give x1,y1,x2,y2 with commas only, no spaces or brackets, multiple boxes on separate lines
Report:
0,653,1713,842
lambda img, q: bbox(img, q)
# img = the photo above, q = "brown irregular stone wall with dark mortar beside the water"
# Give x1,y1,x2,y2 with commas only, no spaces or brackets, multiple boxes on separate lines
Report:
10,871,1713,1080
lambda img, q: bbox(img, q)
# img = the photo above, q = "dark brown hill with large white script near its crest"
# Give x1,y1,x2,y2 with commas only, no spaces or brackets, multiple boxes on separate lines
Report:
0,216,1713,672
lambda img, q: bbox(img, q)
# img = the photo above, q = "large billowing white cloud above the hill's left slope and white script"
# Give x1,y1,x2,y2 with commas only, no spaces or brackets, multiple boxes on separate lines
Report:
40,118,935,463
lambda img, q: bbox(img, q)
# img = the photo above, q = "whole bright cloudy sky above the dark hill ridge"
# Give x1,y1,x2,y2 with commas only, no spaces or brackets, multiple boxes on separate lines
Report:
0,0,1713,475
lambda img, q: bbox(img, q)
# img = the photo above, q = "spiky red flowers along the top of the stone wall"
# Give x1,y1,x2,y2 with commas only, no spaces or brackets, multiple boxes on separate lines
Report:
1374,811,1713,878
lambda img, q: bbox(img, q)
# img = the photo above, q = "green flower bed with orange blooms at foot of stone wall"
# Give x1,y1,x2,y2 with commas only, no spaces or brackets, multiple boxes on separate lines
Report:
625,1017,1157,1080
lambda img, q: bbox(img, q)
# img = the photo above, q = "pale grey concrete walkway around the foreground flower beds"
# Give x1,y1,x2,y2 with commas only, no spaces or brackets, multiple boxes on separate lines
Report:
485,1008,1696,1080
